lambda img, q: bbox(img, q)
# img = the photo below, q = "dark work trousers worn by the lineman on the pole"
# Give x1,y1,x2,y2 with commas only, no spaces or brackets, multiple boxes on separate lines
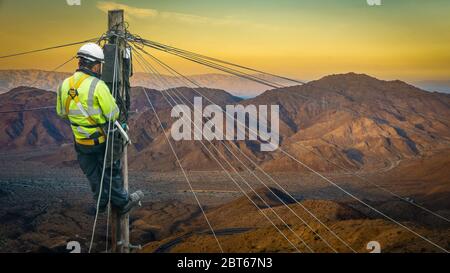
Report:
75,140,128,210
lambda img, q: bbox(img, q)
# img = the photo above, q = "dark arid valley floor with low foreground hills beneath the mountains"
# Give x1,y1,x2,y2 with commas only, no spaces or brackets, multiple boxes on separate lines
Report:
0,143,450,252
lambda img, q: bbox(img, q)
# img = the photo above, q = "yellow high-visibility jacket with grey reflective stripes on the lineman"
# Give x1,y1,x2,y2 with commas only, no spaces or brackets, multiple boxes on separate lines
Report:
56,71,119,145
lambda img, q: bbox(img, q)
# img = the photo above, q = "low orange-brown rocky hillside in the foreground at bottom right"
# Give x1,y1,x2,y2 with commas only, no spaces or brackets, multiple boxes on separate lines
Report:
140,186,450,253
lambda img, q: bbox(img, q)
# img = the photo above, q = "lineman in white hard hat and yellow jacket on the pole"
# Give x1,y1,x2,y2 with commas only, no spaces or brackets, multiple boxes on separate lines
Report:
56,43,143,214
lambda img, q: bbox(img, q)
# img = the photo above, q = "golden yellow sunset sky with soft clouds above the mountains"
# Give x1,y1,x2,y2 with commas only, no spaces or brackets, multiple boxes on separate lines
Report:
0,0,450,81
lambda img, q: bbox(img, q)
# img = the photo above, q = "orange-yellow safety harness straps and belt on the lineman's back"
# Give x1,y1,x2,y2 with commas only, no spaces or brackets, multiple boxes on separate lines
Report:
66,74,106,146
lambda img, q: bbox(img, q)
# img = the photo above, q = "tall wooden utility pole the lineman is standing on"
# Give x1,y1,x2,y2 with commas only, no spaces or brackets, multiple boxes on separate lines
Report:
105,10,130,253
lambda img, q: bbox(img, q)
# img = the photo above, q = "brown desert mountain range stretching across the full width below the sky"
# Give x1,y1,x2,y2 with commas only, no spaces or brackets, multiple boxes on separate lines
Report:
0,73,450,171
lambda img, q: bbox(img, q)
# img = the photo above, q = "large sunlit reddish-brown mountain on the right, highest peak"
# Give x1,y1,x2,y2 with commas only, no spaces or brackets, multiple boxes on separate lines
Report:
245,73,450,169
